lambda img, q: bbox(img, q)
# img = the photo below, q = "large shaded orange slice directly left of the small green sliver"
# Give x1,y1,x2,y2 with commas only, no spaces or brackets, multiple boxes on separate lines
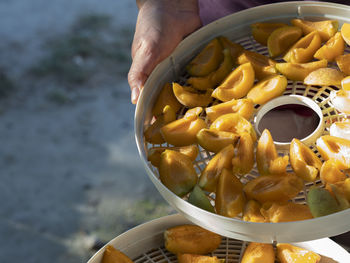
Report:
159,150,198,197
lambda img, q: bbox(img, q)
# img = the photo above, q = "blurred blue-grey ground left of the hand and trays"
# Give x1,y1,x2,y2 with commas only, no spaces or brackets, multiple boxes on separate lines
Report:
0,0,173,263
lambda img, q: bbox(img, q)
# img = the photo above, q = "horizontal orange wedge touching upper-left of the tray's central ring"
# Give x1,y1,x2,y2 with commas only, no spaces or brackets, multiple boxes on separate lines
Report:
205,99,254,123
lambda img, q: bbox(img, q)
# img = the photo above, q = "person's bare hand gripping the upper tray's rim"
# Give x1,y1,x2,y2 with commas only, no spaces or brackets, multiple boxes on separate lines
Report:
128,0,201,104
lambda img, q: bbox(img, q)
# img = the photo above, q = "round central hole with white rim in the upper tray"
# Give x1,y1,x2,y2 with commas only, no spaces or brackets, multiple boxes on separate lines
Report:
254,95,323,150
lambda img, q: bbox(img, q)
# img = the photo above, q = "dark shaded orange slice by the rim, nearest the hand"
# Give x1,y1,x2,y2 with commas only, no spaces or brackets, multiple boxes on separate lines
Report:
186,38,224,77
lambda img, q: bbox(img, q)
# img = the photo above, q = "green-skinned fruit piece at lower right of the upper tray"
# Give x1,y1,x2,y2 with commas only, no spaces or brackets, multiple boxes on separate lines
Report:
306,187,339,217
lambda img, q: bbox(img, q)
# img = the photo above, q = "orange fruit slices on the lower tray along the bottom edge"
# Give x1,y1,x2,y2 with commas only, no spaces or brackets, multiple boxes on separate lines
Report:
101,225,321,263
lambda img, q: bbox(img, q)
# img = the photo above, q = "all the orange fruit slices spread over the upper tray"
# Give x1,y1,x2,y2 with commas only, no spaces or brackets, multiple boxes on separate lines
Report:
144,19,350,222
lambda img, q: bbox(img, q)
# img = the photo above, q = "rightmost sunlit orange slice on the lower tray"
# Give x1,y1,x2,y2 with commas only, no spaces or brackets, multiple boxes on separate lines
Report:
277,243,321,263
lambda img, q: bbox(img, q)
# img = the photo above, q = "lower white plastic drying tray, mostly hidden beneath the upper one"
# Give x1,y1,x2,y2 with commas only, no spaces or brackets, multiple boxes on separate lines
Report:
88,214,350,263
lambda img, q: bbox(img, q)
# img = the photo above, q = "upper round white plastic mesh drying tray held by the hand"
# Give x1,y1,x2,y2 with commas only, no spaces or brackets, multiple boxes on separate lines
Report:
135,2,350,242
